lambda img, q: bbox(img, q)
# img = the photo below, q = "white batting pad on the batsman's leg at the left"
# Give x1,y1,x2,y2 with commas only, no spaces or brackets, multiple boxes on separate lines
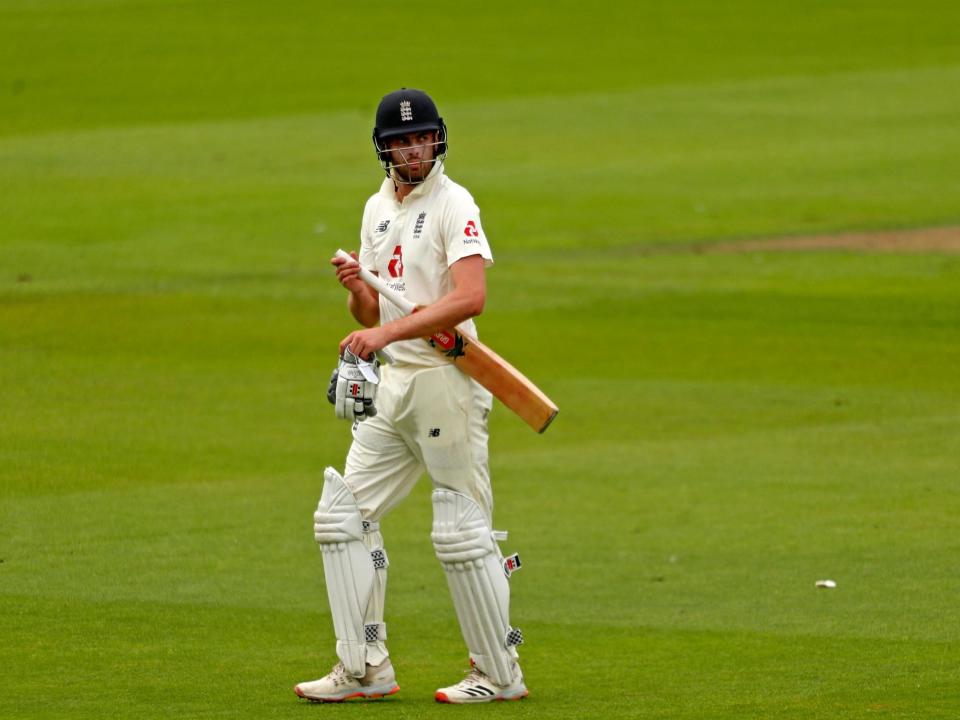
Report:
313,468,375,677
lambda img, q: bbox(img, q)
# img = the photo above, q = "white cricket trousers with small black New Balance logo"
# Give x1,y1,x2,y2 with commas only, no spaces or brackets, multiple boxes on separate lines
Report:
344,365,493,523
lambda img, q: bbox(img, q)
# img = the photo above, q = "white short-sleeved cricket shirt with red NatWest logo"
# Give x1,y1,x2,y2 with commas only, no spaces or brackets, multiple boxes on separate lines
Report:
360,162,493,367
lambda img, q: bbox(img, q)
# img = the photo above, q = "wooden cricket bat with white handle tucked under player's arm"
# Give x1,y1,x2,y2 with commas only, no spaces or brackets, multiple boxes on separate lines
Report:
337,250,559,433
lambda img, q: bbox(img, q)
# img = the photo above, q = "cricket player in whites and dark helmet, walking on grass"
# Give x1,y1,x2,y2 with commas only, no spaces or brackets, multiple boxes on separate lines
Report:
295,88,527,703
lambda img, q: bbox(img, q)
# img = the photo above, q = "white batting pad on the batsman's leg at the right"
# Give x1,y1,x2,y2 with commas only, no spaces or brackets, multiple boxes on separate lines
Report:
430,490,522,685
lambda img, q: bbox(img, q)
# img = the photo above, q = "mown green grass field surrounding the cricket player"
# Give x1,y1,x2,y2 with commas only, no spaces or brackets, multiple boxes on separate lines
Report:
0,0,960,720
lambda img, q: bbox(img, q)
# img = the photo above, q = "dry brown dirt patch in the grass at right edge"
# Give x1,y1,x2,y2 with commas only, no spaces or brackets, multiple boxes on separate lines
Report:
695,226,960,253
